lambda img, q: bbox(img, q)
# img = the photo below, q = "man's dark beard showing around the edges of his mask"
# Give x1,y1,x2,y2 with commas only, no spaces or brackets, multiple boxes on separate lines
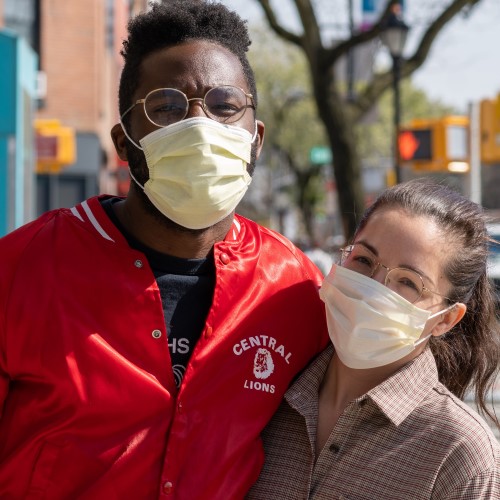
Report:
125,141,257,234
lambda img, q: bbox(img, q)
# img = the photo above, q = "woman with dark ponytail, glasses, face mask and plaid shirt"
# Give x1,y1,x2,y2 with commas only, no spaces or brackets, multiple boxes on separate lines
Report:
249,181,500,500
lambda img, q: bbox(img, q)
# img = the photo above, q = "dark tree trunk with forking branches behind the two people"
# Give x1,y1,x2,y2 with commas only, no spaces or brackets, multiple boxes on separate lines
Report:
254,0,482,239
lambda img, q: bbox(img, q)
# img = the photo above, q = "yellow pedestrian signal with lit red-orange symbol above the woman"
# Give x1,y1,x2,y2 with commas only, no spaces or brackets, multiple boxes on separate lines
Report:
398,116,469,172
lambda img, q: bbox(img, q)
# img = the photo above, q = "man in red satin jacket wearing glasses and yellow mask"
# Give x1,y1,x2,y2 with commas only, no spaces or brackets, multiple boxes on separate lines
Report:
0,0,328,500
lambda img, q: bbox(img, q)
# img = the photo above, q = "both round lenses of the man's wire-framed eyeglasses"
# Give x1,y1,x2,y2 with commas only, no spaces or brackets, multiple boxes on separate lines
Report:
144,86,248,127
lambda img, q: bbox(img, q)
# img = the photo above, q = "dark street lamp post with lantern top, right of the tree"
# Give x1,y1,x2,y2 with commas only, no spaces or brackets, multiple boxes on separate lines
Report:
380,4,410,183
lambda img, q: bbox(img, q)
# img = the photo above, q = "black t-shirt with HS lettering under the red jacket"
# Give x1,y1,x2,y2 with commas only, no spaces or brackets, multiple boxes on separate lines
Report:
101,198,215,387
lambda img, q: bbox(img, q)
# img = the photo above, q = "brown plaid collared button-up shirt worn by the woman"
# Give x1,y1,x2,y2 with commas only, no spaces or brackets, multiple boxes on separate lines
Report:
248,346,500,500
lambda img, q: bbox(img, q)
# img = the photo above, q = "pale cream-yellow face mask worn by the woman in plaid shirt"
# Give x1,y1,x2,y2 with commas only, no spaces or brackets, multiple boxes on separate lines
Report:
319,265,455,369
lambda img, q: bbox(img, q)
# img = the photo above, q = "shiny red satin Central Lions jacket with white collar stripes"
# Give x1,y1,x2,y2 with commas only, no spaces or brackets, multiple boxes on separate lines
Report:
0,197,328,500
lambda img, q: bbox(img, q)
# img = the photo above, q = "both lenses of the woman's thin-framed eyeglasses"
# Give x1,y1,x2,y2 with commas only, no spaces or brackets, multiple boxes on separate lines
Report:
340,245,424,303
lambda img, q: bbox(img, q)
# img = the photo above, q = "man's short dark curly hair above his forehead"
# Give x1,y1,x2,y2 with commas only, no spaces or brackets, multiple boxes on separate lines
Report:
118,0,257,119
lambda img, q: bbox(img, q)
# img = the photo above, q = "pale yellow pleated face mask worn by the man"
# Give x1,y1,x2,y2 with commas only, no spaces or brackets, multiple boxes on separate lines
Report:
130,118,257,229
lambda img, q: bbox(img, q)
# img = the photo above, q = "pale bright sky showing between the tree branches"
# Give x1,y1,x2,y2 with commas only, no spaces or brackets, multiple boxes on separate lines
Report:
222,0,500,112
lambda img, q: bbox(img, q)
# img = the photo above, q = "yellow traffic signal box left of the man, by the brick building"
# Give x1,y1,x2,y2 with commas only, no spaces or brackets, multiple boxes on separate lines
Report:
35,120,76,174
